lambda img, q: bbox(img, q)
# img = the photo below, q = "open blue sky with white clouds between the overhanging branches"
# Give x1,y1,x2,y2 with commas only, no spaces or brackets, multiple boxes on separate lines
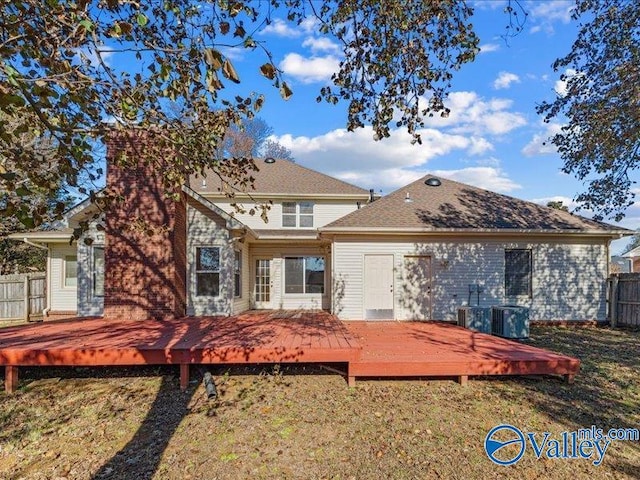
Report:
104,0,640,252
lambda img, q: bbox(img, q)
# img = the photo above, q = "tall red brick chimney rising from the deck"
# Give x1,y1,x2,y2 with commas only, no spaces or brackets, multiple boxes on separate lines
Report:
104,131,187,320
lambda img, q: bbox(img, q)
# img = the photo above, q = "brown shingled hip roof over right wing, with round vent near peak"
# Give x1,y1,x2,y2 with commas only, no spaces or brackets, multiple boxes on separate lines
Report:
320,175,632,235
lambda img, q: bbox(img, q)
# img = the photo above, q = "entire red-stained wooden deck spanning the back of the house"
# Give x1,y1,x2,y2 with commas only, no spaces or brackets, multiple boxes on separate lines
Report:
0,311,580,392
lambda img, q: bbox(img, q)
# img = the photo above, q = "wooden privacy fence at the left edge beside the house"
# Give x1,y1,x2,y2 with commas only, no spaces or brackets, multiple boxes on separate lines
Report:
0,273,46,320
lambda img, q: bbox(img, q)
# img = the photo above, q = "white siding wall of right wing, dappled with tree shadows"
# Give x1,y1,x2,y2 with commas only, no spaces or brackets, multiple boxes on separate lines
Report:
332,237,607,320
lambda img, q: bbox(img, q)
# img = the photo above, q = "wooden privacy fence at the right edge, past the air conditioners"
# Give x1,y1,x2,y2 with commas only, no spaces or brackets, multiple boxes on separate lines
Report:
607,273,640,327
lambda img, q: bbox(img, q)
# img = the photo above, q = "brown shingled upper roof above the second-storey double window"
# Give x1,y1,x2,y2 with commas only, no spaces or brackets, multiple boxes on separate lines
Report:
191,159,369,199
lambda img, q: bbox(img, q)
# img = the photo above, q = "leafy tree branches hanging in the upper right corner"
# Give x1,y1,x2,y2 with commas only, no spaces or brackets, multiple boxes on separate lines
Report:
538,0,640,220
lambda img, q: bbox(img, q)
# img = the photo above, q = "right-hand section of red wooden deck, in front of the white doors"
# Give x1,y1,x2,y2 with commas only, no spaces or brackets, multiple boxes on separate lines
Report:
346,322,580,382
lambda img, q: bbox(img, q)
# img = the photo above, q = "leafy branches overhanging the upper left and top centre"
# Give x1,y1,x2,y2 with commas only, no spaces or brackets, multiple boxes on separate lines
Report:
0,0,478,226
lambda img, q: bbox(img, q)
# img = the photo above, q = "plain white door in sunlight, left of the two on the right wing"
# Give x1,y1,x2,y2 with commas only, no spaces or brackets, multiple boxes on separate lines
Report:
364,255,393,320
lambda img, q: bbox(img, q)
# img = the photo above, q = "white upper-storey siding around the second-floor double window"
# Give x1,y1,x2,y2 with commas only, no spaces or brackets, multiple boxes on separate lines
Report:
214,199,358,230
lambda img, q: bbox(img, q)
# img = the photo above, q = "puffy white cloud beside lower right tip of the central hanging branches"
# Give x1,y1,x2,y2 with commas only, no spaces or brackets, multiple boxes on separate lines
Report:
420,91,527,136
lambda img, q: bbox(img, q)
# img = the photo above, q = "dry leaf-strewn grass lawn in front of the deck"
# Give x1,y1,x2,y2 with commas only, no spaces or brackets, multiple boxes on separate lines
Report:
0,327,640,480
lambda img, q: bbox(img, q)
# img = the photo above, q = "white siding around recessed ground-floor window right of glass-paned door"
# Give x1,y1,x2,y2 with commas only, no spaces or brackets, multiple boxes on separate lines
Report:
251,245,331,310
